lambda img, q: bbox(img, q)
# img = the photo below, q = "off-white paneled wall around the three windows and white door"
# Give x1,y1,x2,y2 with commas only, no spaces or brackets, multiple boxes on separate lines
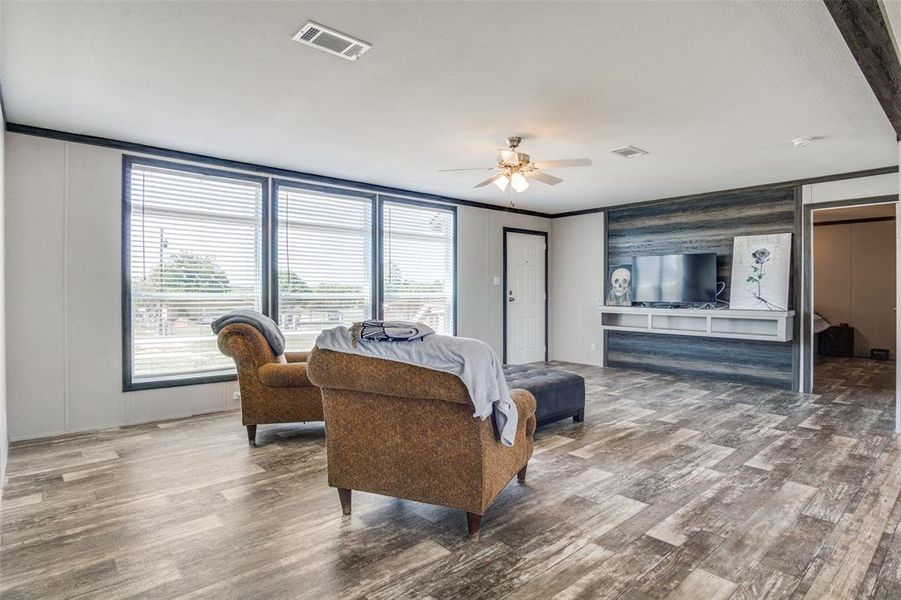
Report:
6,134,550,440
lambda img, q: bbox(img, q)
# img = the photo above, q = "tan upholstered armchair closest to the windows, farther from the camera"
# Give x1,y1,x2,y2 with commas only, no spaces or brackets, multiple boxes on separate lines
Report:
218,323,322,446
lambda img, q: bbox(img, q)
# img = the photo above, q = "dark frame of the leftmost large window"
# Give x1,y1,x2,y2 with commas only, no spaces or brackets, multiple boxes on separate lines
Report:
121,154,270,392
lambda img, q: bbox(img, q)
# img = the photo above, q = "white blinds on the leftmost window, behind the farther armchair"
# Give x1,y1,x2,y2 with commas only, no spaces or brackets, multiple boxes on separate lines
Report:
125,161,266,384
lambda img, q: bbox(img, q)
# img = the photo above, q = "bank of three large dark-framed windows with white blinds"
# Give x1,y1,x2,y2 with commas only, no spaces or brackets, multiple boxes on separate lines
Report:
123,157,457,390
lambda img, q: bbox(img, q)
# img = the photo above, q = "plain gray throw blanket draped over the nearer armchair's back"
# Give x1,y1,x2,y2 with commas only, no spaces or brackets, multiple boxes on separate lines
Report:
316,327,519,446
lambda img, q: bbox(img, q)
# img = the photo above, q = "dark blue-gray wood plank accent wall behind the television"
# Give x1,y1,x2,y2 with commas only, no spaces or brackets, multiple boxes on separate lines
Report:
605,186,800,389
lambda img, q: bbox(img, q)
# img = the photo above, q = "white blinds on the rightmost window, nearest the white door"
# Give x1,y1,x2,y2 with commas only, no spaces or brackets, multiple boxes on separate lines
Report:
382,200,455,335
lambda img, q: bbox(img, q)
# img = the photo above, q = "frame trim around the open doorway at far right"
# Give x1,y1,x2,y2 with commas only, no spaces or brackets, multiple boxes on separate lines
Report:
799,194,901,433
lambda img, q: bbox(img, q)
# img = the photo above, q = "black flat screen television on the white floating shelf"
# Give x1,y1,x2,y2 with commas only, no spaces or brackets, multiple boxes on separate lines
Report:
632,252,716,304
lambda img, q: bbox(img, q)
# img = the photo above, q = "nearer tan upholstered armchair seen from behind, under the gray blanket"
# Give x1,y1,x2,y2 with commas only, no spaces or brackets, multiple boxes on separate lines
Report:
307,348,535,538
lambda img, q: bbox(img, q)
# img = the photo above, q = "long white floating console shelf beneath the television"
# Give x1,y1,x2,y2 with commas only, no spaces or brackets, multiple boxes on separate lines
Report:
597,306,795,342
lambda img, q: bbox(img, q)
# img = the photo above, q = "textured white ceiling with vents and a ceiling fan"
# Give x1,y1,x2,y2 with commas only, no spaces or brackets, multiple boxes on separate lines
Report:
2,0,897,213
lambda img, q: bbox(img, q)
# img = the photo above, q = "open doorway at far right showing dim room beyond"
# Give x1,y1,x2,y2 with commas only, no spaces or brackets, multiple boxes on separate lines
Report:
810,202,897,410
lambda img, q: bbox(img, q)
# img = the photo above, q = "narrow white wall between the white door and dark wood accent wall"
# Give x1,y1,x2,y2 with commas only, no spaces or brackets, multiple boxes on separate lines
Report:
550,213,606,365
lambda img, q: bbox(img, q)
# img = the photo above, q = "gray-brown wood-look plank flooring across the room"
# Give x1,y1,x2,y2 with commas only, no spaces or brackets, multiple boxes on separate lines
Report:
0,360,901,600
